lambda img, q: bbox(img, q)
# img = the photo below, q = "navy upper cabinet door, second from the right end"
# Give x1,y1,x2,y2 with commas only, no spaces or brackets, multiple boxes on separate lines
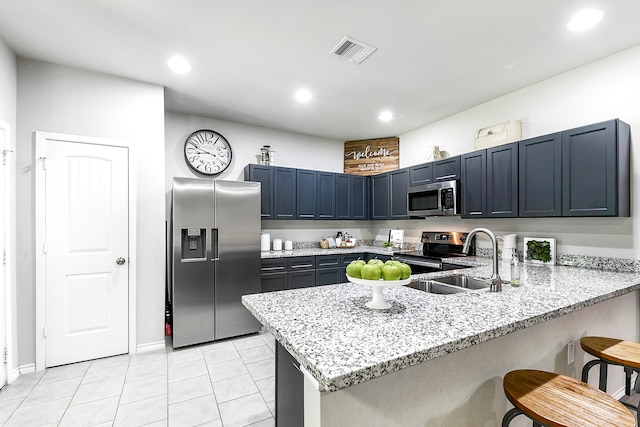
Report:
518,133,562,217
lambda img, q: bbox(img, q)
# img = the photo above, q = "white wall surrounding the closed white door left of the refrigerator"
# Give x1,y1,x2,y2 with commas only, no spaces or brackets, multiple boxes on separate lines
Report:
16,58,165,365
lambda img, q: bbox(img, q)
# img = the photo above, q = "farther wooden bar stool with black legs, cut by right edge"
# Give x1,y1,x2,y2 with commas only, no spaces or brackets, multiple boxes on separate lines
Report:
580,337,640,411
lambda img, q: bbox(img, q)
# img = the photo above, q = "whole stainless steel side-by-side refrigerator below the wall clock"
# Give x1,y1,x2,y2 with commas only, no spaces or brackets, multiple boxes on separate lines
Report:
171,178,261,348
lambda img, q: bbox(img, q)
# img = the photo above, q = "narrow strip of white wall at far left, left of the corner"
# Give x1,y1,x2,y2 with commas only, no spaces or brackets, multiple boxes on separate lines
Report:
0,39,18,373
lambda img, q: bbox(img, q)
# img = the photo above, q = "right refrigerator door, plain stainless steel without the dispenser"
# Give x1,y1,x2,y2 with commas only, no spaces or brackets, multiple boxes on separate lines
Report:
212,180,261,340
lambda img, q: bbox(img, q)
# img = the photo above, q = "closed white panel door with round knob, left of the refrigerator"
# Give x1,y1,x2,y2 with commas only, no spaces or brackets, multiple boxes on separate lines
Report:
44,140,129,367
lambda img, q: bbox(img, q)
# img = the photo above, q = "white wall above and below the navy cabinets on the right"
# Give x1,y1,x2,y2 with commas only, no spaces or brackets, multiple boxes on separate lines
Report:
392,47,640,259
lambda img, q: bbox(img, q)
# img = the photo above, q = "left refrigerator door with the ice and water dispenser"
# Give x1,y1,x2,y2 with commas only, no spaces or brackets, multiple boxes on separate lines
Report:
171,178,215,348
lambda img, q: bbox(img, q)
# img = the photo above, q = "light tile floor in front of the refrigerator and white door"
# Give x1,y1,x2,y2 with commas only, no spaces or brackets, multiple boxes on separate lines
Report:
0,332,275,427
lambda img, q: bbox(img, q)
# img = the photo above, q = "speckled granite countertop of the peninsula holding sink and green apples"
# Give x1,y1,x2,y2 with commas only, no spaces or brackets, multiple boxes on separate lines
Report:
242,260,640,391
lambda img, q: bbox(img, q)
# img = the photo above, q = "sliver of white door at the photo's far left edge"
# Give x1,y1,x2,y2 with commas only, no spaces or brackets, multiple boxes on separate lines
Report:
0,121,10,387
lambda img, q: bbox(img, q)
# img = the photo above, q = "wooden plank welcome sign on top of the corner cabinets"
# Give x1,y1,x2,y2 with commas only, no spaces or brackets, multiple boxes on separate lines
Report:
344,137,400,175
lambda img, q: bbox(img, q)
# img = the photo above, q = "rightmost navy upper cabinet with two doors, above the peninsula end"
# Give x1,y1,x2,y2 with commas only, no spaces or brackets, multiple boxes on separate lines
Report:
519,119,630,217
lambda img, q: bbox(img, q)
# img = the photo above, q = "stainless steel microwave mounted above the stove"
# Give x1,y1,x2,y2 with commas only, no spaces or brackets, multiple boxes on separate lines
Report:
407,180,459,216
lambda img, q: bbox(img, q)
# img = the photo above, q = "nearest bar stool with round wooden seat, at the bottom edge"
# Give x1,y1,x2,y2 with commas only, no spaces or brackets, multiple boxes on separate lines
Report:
502,369,636,427
